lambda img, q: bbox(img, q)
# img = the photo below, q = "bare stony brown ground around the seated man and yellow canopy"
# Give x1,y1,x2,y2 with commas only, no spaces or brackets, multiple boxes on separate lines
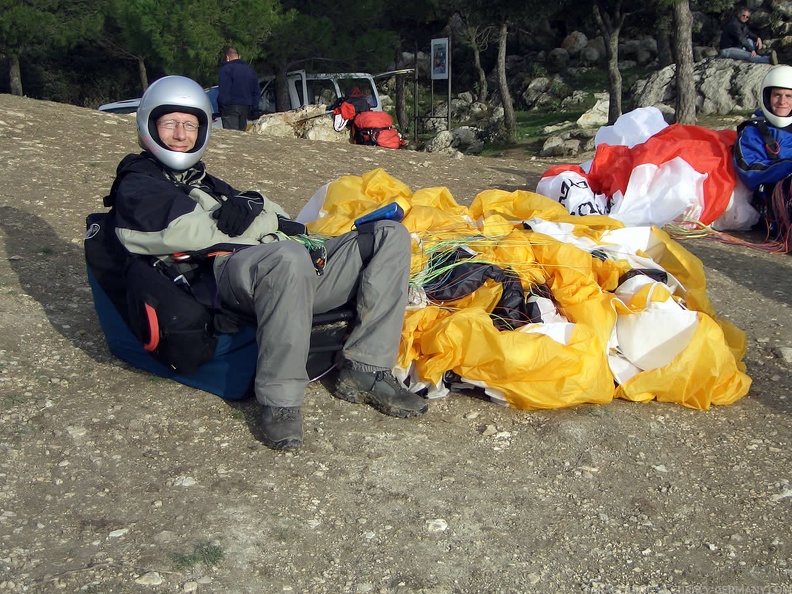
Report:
0,95,792,594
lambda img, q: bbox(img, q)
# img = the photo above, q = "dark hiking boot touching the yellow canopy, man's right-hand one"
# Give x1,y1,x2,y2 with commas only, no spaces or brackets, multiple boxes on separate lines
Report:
335,365,429,418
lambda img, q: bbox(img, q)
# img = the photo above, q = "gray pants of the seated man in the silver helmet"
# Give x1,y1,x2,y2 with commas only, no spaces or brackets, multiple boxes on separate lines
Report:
217,221,410,406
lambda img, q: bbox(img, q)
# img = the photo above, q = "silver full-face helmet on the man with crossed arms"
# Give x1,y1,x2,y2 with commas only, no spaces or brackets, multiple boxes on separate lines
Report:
137,76,212,171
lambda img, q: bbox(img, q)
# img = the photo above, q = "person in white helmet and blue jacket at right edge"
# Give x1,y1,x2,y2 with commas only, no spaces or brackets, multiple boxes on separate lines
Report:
734,66,792,241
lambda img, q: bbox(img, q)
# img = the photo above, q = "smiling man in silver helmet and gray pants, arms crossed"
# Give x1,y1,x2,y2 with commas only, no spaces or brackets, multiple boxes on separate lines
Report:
108,76,427,449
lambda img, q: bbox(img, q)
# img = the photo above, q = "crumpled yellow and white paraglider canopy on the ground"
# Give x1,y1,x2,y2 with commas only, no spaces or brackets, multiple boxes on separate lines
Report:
302,169,751,409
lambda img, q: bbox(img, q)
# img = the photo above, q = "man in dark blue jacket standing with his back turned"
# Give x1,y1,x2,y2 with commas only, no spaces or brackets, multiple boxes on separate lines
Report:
217,46,261,131
